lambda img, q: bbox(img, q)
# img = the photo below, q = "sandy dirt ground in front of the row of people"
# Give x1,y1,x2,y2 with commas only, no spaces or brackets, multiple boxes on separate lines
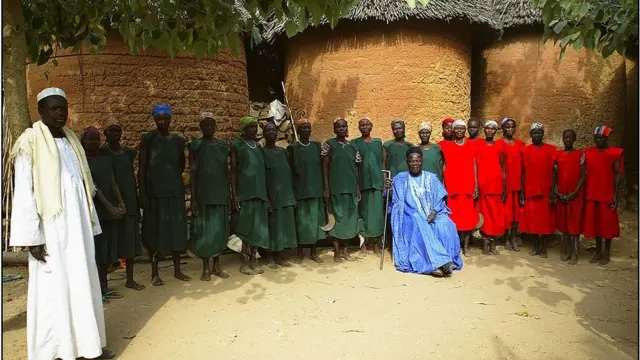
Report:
2,213,638,360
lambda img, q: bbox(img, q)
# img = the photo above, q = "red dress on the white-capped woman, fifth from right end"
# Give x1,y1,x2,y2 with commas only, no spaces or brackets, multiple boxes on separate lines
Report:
476,140,506,236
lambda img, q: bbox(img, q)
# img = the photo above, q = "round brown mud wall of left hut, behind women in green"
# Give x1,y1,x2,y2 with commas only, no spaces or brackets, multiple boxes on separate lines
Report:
27,37,249,147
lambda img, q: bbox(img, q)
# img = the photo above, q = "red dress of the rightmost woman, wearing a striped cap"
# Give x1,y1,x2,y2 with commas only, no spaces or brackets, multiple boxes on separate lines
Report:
584,147,622,239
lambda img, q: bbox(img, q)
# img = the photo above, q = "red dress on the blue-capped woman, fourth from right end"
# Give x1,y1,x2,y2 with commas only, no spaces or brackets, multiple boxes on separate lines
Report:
496,139,525,229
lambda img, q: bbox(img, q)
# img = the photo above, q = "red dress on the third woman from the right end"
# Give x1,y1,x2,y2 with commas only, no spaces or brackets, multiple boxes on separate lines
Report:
519,144,558,235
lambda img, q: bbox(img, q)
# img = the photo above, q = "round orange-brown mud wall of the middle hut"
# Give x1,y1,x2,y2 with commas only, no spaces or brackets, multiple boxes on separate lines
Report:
285,21,471,141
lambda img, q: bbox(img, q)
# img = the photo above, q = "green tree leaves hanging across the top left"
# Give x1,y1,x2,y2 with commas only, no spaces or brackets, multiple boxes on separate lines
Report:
23,0,357,65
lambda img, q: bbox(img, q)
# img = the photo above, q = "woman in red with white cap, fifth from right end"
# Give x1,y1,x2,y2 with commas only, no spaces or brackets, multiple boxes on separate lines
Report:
476,120,507,255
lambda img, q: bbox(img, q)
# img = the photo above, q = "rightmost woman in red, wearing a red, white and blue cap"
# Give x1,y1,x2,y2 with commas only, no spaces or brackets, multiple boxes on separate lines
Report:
584,126,622,265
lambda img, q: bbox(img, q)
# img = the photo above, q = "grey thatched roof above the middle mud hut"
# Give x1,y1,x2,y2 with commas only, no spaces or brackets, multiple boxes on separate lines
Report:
263,0,501,41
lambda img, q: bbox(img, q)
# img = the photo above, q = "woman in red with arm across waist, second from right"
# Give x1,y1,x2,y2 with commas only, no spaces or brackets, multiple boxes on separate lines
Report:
555,129,586,265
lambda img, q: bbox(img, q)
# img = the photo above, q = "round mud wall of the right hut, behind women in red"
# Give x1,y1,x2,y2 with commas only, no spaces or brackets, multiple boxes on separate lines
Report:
473,32,637,151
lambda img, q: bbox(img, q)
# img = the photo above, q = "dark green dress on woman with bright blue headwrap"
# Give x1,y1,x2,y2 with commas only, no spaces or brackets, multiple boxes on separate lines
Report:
142,131,187,255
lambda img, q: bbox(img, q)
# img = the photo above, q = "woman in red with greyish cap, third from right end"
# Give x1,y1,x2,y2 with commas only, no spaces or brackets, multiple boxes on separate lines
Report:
520,122,557,258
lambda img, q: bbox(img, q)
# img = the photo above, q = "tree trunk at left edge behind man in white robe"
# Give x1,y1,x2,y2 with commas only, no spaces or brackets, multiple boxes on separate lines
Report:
2,0,31,140
